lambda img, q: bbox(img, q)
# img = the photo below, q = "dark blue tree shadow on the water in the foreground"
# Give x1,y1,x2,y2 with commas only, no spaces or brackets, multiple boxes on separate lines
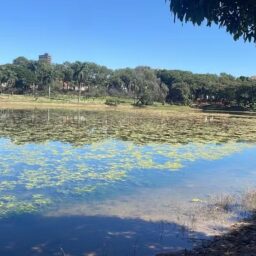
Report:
0,215,209,256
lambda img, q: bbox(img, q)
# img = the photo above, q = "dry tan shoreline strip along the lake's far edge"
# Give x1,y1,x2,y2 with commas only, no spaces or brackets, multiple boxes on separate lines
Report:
0,94,256,117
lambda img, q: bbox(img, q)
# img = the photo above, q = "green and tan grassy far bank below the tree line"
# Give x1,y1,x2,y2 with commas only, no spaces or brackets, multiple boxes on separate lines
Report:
0,94,256,116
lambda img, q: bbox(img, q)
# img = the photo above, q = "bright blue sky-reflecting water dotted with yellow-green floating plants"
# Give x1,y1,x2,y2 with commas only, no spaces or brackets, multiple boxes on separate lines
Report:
0,139,255,215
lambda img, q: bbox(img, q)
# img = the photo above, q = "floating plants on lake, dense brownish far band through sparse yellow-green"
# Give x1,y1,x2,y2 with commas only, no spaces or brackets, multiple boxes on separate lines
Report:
0,110,255,218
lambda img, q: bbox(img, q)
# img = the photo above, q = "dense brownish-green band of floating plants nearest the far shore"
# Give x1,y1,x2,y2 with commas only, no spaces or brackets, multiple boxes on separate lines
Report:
0,109,256,145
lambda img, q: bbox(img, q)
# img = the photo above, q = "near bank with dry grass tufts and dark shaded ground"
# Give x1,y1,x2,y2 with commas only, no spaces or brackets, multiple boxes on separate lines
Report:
157,190,256,256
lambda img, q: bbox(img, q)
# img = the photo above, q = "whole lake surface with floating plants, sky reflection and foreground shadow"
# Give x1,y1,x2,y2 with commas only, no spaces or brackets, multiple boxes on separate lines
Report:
0,110,256,256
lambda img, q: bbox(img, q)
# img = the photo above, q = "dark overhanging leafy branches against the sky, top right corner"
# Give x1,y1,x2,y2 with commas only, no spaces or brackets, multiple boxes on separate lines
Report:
168,0,256,42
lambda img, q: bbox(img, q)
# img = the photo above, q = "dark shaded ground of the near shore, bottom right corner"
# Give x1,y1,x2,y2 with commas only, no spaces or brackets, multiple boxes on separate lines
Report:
157,215,256,256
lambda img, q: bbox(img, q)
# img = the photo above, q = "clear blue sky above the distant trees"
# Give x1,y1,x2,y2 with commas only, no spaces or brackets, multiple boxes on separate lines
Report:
0,0,256,76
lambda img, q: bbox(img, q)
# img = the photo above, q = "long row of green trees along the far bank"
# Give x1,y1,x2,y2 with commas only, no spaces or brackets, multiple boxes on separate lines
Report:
0,57,256,108
